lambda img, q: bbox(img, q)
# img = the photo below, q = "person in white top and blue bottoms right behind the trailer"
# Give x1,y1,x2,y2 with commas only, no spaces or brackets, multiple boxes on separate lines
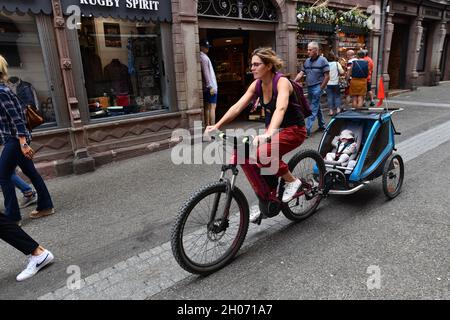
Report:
327,52,345,116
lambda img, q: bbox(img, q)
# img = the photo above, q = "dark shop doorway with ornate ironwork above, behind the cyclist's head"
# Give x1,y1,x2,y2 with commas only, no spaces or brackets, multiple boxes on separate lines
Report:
197,0,286,120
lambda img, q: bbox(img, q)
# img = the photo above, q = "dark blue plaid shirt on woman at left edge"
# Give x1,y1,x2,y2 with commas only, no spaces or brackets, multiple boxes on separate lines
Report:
0,83,31,145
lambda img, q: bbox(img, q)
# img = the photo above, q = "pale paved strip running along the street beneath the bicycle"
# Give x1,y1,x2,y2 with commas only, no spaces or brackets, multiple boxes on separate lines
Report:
38,121,450,300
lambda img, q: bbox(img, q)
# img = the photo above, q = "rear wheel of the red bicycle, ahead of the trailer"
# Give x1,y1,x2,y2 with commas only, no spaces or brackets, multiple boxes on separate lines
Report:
281,150,326,221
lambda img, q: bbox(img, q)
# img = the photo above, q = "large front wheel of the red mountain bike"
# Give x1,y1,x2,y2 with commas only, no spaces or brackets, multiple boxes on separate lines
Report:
171,181,249,275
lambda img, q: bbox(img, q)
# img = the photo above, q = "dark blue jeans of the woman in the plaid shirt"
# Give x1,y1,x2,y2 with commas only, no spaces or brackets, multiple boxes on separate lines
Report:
0,137,53,221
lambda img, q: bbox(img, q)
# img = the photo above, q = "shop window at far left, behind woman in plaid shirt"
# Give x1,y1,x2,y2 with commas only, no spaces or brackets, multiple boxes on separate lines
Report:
0,12,56,130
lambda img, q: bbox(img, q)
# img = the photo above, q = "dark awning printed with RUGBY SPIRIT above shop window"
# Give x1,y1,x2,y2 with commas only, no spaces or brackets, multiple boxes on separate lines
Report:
61,0,172,22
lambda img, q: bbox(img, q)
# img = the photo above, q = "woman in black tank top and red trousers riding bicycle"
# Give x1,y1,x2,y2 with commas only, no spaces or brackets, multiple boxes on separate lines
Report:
205,48,306,222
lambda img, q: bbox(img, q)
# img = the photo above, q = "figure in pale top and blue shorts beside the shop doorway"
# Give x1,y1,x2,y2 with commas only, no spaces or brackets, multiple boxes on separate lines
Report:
200,39,218,126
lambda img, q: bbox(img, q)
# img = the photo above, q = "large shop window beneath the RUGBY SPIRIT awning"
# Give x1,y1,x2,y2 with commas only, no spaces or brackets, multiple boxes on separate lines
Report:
78,17,168,119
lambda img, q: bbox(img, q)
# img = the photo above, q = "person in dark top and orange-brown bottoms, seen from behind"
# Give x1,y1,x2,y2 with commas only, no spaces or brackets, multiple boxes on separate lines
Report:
349,50,369,109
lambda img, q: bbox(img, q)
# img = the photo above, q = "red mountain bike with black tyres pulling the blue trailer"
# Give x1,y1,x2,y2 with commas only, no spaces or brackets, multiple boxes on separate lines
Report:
171,132,326,275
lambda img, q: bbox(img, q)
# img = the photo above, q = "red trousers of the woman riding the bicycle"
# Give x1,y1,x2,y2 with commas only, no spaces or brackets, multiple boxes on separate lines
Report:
257,126,306,177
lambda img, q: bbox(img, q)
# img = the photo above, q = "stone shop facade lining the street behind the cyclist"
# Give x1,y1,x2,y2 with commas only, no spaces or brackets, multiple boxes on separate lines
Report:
0,0,450,176
